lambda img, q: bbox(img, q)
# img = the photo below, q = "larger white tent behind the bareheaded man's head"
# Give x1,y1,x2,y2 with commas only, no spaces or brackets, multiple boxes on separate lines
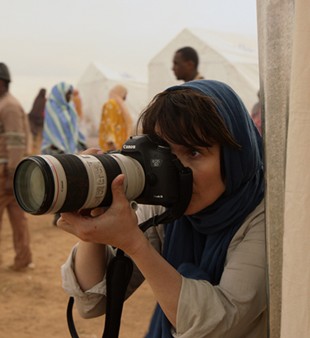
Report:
148,29,259,110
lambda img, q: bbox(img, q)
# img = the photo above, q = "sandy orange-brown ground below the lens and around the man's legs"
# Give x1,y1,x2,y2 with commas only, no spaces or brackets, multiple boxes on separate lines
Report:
0,211,154,338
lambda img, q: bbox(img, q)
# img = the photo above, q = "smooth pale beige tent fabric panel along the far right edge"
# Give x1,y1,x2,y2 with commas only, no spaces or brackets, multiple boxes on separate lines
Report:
281,0,310,338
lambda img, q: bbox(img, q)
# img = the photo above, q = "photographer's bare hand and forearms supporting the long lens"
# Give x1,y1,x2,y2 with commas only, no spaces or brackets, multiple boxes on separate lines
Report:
57,146,182,327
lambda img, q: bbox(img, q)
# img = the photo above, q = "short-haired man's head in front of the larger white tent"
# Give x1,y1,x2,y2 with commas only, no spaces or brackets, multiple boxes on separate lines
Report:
172,47,203,82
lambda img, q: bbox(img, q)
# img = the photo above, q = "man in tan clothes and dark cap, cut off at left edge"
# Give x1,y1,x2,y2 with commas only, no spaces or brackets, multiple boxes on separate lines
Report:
0,62,33,271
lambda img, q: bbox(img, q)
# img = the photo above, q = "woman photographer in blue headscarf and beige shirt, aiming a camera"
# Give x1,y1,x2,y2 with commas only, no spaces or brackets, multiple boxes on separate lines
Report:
58,80,267,338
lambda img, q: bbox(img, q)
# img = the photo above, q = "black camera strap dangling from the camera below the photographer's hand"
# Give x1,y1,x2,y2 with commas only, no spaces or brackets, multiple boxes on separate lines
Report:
67,158,193,338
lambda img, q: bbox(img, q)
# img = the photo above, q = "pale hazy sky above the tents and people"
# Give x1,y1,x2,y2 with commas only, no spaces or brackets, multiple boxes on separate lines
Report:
0,0,257,111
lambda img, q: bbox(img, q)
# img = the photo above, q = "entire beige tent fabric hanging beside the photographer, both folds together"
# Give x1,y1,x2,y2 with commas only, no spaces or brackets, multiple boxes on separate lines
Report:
257,0,310,338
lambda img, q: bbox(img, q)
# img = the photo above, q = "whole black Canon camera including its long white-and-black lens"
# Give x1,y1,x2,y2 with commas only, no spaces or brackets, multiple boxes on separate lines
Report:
14,135,192,215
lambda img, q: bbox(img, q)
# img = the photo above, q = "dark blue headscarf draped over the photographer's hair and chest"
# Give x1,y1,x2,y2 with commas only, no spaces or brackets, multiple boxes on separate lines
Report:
147,80,264,338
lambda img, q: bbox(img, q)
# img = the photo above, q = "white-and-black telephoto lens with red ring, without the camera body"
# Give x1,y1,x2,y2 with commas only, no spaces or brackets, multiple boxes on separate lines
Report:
14,153,145,215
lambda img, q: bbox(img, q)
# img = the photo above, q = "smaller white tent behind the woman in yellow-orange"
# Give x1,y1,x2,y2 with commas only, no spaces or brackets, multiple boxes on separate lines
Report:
76,63,147,137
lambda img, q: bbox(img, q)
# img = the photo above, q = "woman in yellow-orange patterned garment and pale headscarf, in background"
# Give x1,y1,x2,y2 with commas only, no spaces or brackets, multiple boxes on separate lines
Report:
99,85,132,152
